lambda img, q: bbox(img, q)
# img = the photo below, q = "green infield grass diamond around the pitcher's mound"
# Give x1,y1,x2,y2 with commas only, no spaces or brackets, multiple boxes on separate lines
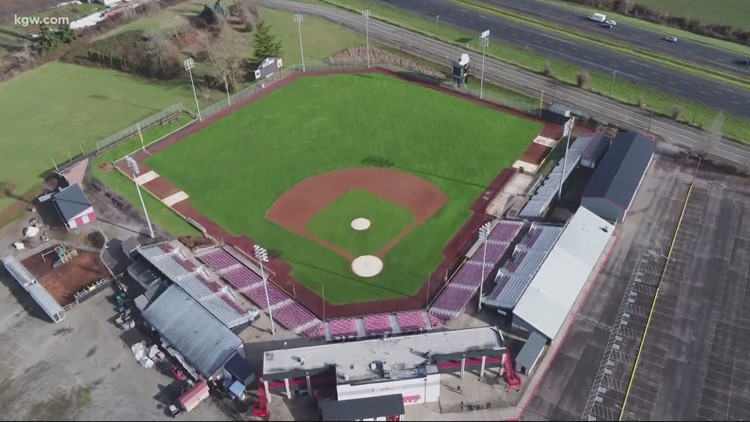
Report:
307,189,414,256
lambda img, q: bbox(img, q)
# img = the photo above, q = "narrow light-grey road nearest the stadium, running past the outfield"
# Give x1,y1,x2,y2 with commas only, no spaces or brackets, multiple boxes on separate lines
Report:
259,0,750,165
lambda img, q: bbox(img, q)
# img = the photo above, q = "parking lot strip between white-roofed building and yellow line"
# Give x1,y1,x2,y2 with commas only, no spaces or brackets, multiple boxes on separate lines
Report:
525,155,691,420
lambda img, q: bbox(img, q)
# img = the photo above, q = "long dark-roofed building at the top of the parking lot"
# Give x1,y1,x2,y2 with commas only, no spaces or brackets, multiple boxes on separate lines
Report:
581,132,656,222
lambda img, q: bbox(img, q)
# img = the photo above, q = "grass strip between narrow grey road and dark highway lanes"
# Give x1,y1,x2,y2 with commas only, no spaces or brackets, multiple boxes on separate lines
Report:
308,0,750,144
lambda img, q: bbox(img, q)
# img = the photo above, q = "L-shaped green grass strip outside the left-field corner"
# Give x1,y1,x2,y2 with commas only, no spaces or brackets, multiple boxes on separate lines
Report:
89,115,200,237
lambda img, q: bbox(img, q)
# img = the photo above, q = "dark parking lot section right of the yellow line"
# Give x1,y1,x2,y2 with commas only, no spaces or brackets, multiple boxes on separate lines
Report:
625,164,750,420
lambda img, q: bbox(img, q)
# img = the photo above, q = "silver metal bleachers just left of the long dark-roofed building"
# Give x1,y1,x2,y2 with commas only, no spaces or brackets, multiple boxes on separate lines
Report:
518,137,590,218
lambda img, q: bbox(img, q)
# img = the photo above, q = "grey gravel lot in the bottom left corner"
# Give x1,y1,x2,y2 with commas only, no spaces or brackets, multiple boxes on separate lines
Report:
0,270,227,420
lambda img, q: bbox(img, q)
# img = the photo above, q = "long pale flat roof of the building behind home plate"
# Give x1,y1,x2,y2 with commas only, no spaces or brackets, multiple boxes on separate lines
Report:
263,326,505,382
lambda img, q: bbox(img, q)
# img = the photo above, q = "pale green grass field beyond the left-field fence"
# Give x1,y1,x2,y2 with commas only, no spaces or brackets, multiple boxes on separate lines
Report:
0,62,221,209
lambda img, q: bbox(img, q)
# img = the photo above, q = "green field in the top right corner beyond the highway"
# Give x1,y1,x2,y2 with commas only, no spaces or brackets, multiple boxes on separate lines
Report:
638,0,750,29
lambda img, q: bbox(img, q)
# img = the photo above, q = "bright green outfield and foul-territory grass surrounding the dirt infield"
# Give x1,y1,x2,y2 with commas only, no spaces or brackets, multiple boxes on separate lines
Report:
146,74,541,303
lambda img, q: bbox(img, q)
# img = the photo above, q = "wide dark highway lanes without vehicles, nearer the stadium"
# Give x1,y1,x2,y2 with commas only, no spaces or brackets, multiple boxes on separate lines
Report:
379,0,750,117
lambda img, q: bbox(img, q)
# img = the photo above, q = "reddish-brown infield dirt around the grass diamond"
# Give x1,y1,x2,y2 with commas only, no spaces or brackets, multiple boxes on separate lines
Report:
266,167,448,259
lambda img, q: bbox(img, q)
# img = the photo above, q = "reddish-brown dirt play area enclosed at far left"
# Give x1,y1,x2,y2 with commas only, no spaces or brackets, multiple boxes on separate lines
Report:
22,246,109,306
